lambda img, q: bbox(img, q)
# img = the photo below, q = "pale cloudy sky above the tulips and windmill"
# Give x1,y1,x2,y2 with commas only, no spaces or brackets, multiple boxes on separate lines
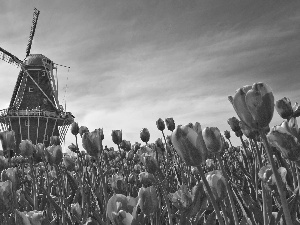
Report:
0,0,300,149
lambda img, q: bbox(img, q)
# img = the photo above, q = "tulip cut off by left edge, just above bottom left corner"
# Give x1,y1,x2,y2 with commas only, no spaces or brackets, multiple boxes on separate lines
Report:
0,180,13,213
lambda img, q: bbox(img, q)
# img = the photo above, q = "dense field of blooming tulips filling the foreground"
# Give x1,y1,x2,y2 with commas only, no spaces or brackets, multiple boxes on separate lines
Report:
0,83,300,225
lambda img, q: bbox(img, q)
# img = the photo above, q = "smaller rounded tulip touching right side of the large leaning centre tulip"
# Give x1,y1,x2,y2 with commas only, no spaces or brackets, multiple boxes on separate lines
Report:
202,127,223,153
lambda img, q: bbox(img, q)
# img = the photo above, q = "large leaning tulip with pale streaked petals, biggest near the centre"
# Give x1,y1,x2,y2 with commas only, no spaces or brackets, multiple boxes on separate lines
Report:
171,123,208,166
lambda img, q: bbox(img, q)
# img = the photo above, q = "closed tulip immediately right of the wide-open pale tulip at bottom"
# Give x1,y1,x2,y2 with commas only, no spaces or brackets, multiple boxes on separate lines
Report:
138,186,158,216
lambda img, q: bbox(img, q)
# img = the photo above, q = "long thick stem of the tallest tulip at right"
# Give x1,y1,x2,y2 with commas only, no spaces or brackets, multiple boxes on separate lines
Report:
259,130,293,225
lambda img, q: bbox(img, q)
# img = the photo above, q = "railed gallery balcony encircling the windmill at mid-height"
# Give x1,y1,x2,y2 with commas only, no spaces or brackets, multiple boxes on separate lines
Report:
0,109,72,119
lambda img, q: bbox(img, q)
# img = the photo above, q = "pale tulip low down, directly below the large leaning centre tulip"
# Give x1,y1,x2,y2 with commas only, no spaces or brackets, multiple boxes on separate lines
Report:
206,170,227,201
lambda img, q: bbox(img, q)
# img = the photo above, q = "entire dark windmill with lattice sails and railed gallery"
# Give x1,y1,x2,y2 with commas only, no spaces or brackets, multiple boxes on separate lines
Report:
0,8,74,154
